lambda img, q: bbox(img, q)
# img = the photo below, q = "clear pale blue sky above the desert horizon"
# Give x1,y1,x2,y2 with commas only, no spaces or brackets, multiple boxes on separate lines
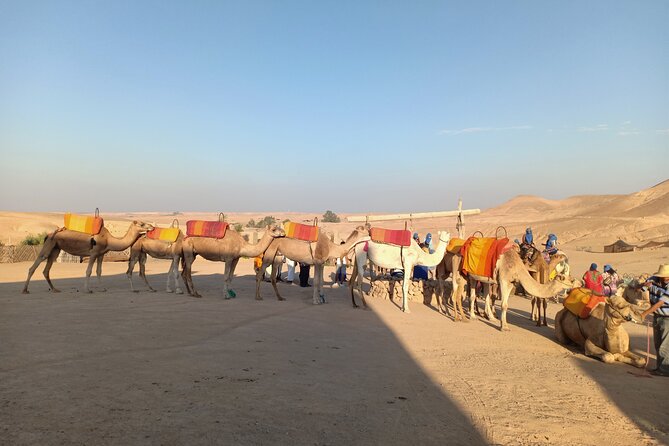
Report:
0,0,669,212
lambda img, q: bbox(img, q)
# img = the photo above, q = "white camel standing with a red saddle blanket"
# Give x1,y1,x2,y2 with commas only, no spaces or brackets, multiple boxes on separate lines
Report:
350,231,451,313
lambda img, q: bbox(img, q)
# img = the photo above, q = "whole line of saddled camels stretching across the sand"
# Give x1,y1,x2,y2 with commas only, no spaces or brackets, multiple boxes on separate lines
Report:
23,209,647,366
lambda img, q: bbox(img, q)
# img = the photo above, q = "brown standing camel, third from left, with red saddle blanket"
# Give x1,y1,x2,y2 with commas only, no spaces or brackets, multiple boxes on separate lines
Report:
181,225,286,299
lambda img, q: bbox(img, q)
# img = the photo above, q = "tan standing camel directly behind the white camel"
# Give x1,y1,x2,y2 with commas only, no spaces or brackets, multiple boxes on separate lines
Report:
256,226,369,305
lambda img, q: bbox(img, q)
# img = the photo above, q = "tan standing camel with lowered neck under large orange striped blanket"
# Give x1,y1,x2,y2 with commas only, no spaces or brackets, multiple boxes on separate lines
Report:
468,249,578,331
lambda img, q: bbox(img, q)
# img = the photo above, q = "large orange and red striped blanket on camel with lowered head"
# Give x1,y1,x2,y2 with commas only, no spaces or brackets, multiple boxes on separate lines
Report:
460,237,513,278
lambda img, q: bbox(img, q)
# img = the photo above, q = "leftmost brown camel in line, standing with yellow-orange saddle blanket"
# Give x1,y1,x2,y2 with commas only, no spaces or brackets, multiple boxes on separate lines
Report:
23,221,153,294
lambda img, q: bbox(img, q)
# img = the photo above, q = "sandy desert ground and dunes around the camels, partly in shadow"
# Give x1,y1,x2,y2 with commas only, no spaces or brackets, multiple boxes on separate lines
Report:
0,181,669,445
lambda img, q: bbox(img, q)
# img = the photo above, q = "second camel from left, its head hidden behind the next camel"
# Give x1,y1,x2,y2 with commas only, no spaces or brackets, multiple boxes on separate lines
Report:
126,231,184,294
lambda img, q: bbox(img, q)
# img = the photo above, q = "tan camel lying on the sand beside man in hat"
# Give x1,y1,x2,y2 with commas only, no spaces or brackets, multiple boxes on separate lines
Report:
555,287,646,367
